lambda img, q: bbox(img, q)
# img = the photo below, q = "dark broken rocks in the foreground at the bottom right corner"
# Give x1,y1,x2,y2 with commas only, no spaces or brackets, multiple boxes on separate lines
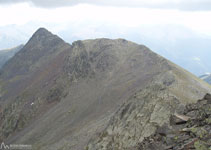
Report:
139,94,211,150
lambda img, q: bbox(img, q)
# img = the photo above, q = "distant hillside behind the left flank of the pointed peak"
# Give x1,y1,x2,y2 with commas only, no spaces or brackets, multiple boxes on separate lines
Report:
0,45,24,68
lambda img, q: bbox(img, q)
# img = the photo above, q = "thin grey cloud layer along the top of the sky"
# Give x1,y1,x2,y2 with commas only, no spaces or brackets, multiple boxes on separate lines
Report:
0,0,211,10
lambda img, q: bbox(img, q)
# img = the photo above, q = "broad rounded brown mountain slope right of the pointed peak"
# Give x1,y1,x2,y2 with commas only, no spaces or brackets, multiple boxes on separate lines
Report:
0,28,210,150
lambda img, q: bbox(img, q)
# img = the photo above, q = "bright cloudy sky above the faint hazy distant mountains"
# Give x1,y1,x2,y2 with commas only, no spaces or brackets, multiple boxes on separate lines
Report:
0,0,211,35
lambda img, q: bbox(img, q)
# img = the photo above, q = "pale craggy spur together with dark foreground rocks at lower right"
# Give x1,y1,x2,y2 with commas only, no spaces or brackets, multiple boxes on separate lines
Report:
87,85,211,150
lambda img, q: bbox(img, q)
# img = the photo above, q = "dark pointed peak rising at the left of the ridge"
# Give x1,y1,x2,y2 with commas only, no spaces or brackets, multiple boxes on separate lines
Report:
0,28,69,78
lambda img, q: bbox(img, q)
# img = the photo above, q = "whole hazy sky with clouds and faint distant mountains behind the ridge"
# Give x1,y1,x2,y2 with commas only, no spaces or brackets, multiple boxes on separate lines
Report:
0,0,211,75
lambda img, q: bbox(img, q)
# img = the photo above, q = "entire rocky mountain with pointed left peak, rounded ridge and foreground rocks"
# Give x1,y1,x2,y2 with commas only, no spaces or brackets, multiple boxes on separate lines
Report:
0,28,211,150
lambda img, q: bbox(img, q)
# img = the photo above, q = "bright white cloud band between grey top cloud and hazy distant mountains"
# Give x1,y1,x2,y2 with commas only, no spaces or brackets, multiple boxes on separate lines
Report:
0,1,211,35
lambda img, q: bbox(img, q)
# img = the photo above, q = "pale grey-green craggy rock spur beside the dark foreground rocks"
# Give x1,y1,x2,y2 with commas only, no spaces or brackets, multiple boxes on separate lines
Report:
88,85,173,150
